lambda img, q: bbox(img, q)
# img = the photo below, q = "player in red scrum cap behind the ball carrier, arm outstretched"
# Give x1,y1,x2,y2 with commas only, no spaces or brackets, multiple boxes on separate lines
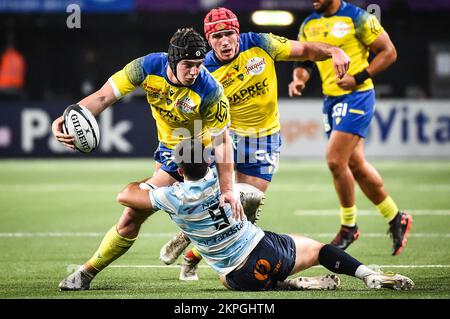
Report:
161,8,350,279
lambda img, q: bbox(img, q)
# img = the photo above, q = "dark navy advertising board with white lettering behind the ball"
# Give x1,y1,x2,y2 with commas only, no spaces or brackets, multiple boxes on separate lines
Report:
0,102,157,157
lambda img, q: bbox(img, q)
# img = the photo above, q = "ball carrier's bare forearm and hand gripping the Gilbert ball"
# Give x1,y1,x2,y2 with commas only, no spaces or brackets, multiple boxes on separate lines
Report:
52,82,117,150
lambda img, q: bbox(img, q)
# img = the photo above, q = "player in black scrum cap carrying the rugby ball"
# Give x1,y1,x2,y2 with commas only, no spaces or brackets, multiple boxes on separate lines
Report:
52,28,243,290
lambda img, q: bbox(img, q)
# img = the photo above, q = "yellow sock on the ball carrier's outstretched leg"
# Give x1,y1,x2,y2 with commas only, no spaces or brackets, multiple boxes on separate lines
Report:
88,225,136,271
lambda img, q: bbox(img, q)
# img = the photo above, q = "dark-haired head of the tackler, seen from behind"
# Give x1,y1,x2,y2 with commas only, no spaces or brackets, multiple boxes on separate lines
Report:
174,139,210,180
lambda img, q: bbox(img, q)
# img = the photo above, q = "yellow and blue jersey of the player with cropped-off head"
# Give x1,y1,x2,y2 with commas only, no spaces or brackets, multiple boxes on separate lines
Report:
298,1,383,96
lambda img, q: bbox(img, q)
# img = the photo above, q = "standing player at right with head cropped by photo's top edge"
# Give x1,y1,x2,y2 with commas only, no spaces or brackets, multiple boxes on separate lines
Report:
289,0,412,255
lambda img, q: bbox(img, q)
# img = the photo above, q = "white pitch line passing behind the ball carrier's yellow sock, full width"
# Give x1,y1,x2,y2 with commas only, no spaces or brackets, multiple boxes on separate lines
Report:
0,232,450,238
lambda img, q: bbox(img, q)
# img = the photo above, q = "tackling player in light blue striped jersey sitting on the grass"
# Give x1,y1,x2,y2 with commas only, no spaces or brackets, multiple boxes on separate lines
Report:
113,140,414,291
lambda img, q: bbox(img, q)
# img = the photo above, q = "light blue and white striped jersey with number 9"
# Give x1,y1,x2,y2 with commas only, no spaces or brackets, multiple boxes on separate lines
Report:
150,169,264,275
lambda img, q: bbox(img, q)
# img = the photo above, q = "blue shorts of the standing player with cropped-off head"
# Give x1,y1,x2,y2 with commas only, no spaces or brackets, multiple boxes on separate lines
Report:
323,90,375,138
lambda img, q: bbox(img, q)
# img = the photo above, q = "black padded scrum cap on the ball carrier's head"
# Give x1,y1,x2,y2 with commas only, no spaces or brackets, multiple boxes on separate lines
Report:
167,28,206,76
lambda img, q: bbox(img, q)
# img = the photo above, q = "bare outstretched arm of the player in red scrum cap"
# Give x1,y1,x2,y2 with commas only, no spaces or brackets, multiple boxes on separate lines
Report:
290,40,350,79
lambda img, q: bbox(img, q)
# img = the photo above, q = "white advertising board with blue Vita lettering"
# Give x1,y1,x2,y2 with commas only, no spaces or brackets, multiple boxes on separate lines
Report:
279,98,450,158
